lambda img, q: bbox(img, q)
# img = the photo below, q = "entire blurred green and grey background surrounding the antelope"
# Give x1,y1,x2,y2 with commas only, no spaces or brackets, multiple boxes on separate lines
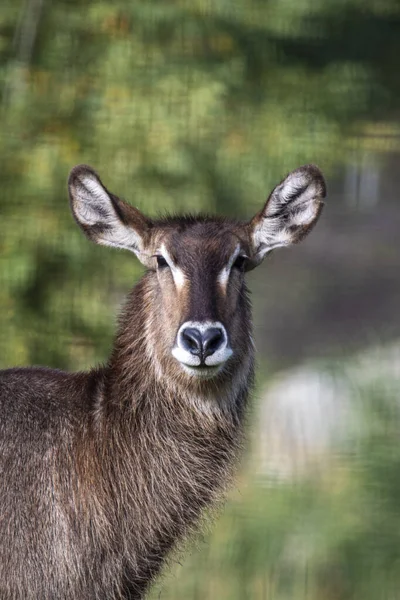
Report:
0,0,400,600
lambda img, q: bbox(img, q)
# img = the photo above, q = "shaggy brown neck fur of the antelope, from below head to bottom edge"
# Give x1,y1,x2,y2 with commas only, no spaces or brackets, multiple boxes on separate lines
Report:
69,274,253,598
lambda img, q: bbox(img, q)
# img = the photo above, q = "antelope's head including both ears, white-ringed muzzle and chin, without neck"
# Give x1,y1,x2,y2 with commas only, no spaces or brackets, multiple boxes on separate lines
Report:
68,165,325,381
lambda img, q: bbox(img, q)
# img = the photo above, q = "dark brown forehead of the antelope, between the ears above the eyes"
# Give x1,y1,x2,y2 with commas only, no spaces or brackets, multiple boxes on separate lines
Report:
152,217,248,261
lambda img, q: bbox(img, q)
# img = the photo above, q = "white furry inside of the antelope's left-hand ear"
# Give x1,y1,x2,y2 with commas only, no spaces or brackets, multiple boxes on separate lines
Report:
74,176,143,256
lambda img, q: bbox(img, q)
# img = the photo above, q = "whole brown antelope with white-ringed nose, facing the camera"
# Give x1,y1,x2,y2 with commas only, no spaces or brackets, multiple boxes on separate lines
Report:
0,165,326,600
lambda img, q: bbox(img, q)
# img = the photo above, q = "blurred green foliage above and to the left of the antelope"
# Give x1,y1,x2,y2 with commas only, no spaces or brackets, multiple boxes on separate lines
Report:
0,0,400,368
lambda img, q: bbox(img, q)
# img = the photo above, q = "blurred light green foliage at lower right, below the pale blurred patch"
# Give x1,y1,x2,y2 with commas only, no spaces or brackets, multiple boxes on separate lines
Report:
150,381,400,600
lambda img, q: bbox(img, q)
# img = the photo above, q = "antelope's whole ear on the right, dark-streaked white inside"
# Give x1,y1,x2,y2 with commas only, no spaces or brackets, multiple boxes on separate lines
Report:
249,165,326,267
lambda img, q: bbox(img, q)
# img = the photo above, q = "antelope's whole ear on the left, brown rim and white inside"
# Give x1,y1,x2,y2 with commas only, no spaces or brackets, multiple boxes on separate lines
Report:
68,165,151,264
